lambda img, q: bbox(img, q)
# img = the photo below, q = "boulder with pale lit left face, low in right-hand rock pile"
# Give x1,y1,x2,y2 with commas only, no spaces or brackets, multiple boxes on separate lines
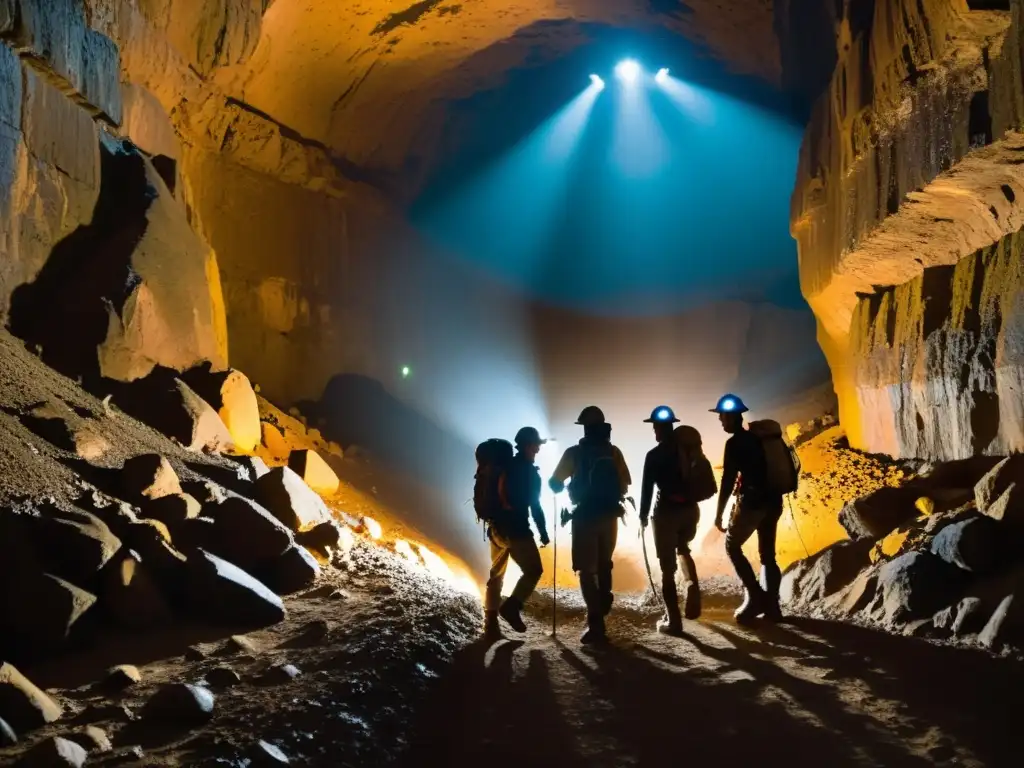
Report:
867,552,962,629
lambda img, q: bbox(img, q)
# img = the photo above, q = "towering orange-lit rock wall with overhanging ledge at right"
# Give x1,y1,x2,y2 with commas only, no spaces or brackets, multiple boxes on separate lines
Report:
792,0,1024,459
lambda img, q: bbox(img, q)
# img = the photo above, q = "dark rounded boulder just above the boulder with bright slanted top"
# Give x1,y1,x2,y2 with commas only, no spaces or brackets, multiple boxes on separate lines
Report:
203,495,293,568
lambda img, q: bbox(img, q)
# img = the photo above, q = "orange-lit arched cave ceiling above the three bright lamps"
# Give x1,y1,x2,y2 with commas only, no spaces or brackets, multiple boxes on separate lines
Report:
213,0,781,198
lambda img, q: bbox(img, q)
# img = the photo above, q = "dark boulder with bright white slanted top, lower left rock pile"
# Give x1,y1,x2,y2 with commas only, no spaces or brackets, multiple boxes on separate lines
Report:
188,550,286,628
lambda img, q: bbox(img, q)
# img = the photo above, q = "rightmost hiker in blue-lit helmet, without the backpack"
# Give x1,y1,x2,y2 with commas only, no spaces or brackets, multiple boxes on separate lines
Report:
711,394,782,623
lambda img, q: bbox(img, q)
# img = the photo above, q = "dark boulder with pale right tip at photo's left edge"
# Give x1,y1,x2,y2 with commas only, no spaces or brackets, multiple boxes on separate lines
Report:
0,570,96,655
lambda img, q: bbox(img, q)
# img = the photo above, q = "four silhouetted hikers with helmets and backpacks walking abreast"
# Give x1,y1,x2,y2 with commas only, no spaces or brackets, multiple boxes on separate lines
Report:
474,394,800,644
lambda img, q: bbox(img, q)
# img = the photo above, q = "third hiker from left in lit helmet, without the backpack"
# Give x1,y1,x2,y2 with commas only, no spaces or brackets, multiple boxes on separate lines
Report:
640,406,700,635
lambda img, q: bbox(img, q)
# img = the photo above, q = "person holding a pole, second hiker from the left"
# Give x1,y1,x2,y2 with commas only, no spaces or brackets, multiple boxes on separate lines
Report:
548,406,633,643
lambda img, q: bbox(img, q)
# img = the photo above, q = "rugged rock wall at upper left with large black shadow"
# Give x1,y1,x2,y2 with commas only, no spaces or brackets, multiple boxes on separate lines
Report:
0,0,227,379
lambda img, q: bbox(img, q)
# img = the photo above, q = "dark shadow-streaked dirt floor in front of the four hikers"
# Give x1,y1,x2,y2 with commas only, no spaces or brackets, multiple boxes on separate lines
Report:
401,597,1024,768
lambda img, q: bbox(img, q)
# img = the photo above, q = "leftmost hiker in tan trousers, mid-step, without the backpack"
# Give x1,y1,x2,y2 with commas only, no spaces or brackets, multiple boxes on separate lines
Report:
484,427,549,636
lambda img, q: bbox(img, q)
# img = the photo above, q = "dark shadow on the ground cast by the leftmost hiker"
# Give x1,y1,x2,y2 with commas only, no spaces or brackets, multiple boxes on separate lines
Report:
397,640,584,768
